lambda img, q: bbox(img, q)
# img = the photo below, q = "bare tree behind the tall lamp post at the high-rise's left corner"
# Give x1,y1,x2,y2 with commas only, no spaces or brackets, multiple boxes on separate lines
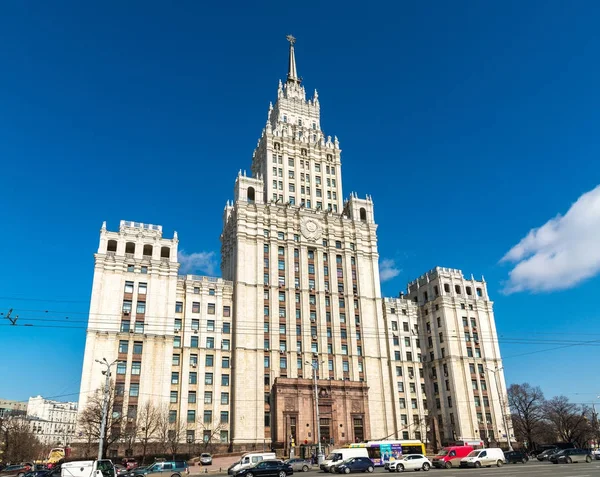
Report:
79,383,124,457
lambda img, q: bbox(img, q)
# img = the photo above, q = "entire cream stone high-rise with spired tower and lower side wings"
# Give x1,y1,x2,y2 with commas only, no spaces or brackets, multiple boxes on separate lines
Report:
79,36,512,454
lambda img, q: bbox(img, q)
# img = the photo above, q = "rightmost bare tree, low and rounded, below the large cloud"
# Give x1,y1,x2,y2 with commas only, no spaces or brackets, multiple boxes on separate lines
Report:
544,396,593,446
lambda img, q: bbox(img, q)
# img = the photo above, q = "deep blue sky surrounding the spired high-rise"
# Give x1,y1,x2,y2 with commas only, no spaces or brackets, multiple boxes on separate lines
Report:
0,0,600,408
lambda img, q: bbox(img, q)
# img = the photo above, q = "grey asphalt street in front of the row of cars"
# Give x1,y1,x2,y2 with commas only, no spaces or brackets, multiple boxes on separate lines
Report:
190,459,600,477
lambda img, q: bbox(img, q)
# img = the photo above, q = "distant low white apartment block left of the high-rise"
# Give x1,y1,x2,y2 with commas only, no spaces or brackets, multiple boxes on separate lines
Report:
27,396,77,446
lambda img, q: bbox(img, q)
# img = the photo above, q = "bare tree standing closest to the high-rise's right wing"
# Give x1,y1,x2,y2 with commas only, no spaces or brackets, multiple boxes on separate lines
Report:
508,383,545,449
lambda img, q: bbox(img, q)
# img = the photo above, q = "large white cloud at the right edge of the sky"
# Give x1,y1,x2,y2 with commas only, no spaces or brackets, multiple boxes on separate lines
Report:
501,185,600,293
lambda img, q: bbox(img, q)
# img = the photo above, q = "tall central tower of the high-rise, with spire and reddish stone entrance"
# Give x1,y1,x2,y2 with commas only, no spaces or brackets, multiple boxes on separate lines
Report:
221,36,395,449
